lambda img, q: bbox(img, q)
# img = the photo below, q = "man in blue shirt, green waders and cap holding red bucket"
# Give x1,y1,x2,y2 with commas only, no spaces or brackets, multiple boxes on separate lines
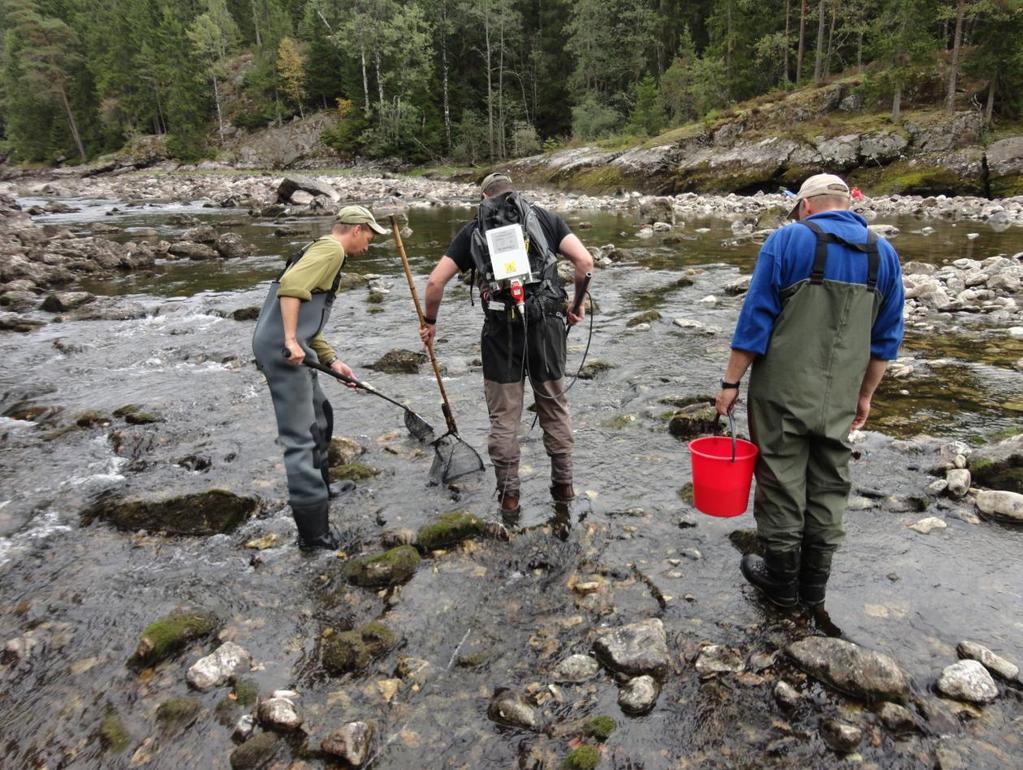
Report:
716,174,904,607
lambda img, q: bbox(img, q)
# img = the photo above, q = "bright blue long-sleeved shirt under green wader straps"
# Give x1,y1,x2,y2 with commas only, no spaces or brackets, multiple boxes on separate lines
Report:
731,211,905,361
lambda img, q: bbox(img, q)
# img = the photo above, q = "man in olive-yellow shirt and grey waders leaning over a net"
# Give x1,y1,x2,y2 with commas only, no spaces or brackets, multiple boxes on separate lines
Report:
253,206,387,551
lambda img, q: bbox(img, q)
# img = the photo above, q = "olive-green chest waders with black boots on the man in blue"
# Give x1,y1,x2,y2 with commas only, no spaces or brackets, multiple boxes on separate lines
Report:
743,221,881,605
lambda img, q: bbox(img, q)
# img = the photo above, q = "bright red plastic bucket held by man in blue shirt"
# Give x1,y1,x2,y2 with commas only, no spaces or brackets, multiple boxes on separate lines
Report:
690,415,757,516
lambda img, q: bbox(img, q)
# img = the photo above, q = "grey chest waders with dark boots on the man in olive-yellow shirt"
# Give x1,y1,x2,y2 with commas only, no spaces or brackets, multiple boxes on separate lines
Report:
253,240,344,549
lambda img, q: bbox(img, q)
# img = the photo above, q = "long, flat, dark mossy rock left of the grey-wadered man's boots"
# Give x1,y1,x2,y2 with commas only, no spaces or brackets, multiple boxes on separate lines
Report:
82,489,260,536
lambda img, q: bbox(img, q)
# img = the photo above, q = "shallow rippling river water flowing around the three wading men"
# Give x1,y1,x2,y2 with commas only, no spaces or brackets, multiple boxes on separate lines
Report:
0,193,1023,770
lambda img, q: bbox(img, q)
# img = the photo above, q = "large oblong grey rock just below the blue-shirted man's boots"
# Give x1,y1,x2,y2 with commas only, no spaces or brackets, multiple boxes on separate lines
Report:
785,636,909,700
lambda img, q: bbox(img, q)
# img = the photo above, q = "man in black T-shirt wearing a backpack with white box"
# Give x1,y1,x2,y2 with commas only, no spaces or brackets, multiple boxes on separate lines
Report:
420,173,593,514
